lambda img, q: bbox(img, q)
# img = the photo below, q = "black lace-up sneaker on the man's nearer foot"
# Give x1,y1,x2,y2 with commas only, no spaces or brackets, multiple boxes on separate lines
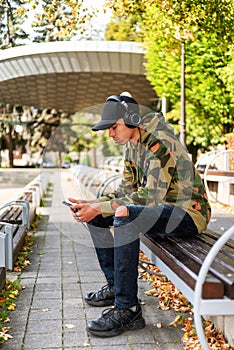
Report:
87,304,145,338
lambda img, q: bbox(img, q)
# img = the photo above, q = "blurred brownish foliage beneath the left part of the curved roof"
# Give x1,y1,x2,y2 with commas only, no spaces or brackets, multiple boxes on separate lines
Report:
0,105,71,167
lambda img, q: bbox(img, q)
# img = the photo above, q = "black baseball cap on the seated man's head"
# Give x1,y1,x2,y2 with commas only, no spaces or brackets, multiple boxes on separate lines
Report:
92,93,139,131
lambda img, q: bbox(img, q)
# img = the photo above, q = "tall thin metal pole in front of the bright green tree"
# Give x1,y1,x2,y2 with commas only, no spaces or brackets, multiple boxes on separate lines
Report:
180,41,187,149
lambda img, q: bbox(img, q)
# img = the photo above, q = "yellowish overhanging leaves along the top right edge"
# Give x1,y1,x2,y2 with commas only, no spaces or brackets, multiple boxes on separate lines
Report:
106,0,234,43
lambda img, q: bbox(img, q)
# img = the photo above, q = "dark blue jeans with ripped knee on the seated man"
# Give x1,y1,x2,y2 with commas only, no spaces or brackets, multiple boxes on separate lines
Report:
88,204,198,308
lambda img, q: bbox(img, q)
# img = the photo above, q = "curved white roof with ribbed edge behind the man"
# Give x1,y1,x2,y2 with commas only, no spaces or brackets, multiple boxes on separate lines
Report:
0,41,156,111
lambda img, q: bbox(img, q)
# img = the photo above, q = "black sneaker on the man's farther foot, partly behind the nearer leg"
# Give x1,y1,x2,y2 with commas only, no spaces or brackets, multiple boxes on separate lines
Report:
85,284,115,306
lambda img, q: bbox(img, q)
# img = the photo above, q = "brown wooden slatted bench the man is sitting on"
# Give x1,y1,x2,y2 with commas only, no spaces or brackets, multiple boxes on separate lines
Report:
140,226,234,350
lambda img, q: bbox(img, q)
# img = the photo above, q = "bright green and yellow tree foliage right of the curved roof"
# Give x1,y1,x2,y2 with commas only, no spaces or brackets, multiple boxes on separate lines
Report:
106,0,234,152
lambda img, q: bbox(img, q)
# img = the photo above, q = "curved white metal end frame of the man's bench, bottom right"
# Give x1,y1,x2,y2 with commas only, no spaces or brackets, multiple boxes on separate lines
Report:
194,225,234,350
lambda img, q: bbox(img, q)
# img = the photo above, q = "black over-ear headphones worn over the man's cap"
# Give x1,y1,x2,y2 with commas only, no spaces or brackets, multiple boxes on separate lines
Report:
106,95,142,129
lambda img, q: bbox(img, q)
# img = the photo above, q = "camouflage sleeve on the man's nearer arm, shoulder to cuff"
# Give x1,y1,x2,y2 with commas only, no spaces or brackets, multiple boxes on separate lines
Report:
98,141,175,214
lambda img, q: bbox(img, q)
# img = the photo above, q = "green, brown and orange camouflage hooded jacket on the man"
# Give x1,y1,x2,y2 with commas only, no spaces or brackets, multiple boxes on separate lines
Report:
100,113,211,232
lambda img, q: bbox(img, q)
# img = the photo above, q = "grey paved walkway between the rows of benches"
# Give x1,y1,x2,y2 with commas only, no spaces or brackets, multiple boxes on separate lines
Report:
1,170,234,350
